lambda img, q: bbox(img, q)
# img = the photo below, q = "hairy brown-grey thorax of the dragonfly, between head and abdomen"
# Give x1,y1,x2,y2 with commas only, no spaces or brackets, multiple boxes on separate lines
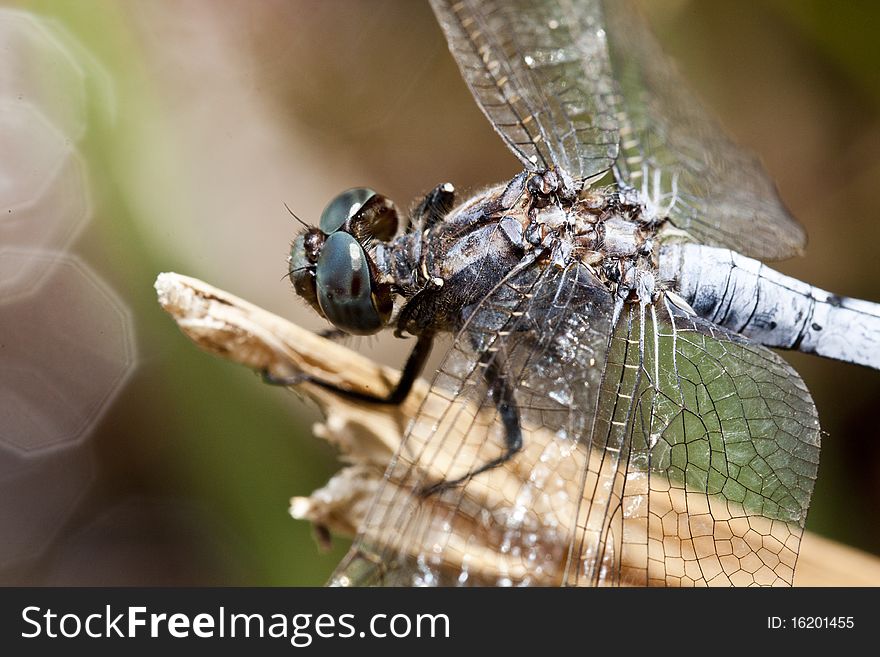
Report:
384,169,659,334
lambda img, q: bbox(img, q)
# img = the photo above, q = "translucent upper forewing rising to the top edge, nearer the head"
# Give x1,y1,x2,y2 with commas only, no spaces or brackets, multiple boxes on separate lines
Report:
431,0,619,179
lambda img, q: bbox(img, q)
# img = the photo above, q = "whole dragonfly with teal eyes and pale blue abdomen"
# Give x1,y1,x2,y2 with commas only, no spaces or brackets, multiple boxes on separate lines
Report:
280,0,880,586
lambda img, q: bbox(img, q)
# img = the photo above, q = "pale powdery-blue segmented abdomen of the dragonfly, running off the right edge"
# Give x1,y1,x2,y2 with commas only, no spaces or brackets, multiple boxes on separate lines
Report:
660,244,880,369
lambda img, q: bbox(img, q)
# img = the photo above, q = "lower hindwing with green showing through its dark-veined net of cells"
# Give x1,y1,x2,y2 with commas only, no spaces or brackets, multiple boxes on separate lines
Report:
566,301,819,586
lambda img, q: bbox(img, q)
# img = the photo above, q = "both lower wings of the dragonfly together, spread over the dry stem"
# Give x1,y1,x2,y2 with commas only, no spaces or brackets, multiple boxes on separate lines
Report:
334,282,819,586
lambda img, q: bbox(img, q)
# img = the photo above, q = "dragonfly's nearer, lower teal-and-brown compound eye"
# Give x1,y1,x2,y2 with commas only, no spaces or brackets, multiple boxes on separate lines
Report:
315,229,384,335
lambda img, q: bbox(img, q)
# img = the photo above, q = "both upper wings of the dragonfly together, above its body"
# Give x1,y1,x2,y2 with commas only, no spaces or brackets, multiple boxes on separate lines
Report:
431,0,806,259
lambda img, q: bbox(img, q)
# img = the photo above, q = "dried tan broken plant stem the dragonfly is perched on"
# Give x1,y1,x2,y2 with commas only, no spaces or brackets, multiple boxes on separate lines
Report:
156,273,880,586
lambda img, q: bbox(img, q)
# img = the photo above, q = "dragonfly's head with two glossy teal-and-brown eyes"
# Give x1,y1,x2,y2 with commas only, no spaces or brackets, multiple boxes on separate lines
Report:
288,187,398,335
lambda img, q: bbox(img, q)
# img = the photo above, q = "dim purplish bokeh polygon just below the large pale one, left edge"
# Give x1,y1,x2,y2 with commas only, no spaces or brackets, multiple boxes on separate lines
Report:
0,445,95,568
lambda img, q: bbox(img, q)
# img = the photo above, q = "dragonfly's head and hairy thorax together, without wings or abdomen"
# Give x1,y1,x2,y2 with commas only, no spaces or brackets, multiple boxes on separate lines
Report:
290,169,658,335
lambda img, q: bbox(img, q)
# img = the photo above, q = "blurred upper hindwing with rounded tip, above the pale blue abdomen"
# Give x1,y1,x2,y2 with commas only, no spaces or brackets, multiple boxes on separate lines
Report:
600,0,806,259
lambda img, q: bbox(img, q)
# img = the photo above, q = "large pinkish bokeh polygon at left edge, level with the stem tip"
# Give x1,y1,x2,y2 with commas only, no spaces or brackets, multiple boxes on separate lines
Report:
0,249,136,455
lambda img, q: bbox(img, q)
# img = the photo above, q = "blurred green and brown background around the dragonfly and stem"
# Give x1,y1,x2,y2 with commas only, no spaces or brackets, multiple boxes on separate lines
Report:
0,0,880,585
